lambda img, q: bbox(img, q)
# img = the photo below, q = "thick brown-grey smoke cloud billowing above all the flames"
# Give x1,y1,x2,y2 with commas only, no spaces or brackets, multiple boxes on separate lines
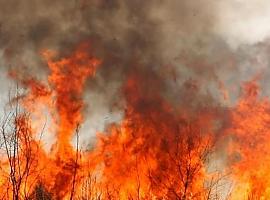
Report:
0,0,269,150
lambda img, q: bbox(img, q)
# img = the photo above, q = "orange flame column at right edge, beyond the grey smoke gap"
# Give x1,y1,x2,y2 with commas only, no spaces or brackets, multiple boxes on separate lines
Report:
230,80,270,199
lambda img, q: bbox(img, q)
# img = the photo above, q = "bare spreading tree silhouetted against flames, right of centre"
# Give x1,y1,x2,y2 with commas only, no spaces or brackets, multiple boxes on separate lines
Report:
143,124,228,200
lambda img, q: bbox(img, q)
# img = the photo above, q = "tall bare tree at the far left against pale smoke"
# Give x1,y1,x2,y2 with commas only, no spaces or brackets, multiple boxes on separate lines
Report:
0,88,42,200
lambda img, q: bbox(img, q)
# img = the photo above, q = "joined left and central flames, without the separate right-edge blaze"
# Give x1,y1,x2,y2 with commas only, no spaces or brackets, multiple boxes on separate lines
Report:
1,44,221,200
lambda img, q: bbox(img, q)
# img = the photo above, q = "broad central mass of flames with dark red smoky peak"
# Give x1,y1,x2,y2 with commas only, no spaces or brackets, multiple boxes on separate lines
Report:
86,72,217,199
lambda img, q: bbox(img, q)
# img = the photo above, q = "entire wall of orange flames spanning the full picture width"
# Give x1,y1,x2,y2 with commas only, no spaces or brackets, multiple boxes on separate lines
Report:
0,39,270,200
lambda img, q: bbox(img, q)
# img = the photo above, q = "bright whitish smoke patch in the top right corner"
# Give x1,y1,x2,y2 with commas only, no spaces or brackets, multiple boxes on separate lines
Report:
216,0,270,48
